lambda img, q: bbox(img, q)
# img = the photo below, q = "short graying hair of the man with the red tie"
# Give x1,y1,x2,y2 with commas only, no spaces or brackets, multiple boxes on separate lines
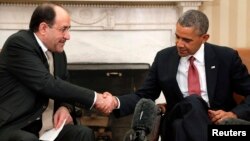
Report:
177,10,209,35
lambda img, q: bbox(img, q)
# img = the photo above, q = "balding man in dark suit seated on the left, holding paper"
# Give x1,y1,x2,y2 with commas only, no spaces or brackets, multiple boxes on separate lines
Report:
0,4,112,141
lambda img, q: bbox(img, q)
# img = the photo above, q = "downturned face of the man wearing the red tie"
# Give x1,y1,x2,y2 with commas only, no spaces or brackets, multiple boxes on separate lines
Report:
175,23,209,57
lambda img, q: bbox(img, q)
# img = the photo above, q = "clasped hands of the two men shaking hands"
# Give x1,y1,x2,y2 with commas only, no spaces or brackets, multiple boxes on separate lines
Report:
94,92,118,115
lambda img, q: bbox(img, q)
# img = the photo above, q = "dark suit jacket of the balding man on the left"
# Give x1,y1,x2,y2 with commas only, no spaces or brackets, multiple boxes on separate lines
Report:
0,30,94,131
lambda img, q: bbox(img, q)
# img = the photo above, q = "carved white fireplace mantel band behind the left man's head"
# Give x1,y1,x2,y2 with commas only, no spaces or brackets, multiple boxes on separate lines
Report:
0,4,178,30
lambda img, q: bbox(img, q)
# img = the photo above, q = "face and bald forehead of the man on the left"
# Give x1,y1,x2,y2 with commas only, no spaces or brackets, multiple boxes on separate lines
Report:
44,7,70,52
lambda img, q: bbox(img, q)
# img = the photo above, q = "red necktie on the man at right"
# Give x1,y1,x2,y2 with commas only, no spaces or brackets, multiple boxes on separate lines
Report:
188,56,201,95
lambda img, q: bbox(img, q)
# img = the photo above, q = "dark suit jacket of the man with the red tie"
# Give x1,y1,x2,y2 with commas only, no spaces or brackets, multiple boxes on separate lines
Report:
115,43,250,120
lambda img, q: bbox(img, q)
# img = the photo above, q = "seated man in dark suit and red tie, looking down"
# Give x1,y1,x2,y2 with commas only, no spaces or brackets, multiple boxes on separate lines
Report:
98,10,250,141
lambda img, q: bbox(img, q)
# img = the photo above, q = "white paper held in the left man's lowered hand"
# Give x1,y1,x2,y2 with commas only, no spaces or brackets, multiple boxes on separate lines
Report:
39,119,66,141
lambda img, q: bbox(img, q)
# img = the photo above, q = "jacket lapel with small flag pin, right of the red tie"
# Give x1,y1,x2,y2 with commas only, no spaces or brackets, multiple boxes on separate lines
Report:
204,43,219,104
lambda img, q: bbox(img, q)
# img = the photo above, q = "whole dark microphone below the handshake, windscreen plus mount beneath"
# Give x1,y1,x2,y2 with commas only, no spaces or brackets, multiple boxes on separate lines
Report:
124,98,158,141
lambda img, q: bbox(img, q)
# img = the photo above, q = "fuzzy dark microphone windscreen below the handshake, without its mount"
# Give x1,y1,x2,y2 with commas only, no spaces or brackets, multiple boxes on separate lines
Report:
132,98,157,134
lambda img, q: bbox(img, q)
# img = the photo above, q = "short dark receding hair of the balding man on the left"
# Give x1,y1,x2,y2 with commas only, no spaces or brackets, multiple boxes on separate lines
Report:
29,3,56,32
